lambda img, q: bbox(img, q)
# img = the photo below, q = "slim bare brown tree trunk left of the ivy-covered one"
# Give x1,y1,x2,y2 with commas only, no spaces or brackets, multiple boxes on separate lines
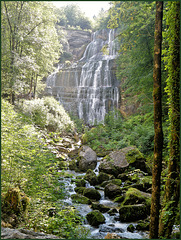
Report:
150,1,163,239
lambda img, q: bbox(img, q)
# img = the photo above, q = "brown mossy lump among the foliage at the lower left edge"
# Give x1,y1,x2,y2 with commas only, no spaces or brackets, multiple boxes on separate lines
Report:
2,188,30,216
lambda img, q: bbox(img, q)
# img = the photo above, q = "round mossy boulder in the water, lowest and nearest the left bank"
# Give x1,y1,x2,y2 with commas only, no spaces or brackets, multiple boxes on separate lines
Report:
86,210,106,227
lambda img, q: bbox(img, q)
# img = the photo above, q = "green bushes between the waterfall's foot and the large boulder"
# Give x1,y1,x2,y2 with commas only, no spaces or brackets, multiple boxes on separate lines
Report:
83,109,154,155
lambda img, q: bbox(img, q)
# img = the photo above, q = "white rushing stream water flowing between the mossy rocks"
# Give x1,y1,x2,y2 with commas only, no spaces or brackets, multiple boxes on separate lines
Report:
59,158,148,239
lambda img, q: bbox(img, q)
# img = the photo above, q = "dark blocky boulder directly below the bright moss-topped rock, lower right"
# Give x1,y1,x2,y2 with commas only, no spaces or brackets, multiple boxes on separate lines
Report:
119,204,150,222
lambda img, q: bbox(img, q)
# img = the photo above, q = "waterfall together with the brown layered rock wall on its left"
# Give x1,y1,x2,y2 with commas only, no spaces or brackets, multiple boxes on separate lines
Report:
46,29,119,124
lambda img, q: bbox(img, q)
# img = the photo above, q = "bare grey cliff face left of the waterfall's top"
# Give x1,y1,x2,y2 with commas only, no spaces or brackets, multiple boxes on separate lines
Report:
63,29,91,61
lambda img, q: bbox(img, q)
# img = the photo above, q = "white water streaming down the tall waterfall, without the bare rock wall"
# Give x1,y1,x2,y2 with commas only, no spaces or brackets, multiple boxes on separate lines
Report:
77,29,119,124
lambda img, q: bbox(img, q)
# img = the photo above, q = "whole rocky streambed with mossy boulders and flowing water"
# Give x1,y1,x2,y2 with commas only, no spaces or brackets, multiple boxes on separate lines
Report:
55,138,151,239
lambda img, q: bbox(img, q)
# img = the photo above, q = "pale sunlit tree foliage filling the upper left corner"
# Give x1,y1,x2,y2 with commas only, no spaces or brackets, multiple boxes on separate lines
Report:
1,1,61,100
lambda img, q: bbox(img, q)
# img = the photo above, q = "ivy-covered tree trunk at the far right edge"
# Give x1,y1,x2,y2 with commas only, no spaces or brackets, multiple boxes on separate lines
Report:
159,2,180,239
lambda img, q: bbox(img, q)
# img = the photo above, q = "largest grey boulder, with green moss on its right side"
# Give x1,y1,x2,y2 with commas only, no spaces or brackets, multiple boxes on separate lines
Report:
99,147,151,178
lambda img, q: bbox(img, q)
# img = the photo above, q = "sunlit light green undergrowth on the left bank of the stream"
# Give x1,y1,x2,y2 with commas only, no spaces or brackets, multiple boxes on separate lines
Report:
1,99,87,238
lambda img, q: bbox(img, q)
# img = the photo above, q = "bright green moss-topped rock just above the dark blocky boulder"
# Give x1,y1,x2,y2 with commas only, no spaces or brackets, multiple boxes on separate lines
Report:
122,188,151,208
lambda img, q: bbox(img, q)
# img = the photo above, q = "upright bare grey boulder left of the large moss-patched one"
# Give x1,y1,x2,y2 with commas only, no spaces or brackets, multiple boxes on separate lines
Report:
79,145,97,172
